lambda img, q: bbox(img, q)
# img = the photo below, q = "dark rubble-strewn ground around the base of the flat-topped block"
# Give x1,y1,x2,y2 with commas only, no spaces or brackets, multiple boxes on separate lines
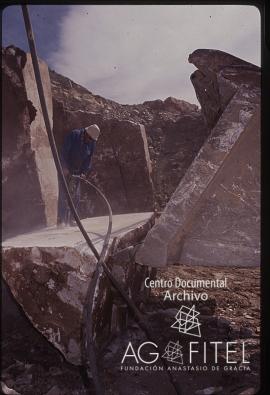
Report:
2,266,260,395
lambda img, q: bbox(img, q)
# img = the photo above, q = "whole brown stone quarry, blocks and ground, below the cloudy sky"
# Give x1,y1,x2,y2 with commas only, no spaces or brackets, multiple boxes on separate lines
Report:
2,46,260,395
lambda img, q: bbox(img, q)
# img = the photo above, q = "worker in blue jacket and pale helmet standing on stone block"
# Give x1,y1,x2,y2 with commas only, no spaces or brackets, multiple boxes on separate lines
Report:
58,124,100,227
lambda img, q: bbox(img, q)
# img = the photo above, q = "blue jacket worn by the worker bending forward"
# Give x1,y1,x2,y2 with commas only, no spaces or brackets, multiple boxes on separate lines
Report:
60,128,96,174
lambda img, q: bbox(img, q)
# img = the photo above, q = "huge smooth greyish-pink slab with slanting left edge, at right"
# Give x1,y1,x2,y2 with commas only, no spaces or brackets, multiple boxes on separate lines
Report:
136,51,260,266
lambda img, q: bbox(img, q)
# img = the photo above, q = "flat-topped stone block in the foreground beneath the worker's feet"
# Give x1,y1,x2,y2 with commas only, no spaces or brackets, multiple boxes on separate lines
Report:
2,213,153,365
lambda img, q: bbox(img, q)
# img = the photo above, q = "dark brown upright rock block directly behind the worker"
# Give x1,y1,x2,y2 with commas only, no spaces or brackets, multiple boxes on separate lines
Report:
51,105,154,217
